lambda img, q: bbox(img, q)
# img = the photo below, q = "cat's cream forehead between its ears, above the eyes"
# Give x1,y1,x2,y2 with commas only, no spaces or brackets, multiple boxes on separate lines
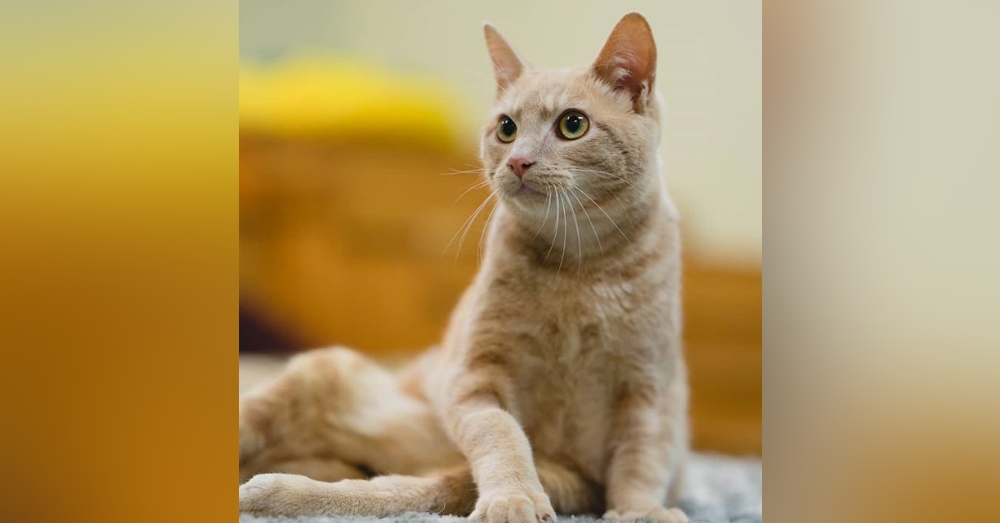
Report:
496,69,593,117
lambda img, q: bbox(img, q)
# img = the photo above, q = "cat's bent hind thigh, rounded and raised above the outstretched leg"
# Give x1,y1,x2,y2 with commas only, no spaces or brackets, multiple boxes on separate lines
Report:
239,347,462,483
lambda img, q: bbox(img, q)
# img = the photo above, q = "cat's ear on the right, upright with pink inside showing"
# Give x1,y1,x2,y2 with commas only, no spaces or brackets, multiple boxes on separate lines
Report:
592,13,656,113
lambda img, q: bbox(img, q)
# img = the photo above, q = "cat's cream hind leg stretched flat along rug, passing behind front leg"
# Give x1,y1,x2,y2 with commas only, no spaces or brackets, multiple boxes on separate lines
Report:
240,461,604,517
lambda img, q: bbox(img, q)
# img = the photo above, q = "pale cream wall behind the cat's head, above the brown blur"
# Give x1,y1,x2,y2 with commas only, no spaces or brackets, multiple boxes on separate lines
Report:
240,0,763,264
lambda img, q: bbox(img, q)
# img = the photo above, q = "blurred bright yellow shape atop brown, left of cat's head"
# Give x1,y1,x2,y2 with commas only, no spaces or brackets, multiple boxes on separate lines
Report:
240,54,459,150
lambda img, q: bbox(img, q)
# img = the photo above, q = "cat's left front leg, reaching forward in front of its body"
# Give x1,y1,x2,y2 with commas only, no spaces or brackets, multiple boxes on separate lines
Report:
444,360,556,523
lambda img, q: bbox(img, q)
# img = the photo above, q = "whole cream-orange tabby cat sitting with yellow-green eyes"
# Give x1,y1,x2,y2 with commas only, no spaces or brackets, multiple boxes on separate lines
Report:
239,13,688,523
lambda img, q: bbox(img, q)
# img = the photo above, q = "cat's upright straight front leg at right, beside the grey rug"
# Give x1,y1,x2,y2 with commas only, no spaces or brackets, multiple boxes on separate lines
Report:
604,376,688,523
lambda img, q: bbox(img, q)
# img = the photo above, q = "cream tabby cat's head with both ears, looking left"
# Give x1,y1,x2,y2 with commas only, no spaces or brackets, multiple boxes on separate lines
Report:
481,13,660,223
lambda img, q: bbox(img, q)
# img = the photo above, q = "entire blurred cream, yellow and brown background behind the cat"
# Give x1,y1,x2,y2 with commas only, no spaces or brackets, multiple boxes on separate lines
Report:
240,0,763,454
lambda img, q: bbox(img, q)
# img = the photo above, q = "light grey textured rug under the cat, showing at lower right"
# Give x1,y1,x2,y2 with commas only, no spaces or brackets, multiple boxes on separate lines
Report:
240,454,764,523
